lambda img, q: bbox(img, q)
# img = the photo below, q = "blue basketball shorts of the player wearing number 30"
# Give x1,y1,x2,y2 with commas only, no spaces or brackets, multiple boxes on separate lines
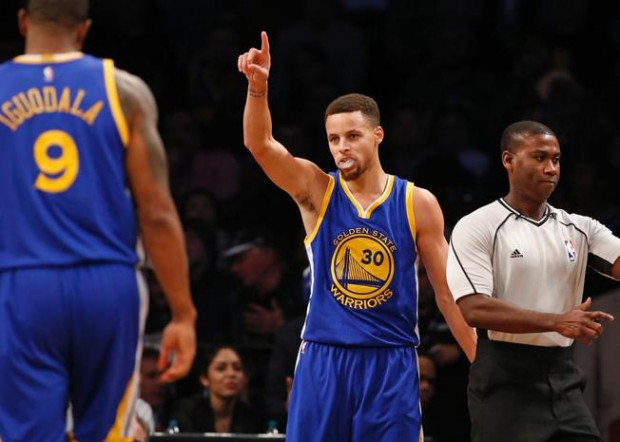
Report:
286,341,422,442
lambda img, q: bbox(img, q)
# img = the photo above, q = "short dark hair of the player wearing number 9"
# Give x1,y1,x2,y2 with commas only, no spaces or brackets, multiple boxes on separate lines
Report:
25,0,89,27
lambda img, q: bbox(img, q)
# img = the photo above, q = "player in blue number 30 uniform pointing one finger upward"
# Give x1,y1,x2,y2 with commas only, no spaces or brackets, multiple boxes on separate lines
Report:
238,32,475,442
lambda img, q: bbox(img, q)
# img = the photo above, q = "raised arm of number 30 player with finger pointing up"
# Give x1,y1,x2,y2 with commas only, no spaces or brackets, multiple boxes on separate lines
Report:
238,32,329,234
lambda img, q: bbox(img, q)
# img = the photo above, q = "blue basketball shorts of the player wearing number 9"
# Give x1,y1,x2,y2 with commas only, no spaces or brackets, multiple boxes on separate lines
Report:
0,264,148,442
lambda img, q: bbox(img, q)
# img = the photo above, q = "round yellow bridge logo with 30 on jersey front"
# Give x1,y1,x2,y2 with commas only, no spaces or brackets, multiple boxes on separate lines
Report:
331,227,396,309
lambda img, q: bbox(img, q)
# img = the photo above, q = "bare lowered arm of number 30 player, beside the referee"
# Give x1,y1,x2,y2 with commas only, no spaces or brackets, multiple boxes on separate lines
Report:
409,187,476,361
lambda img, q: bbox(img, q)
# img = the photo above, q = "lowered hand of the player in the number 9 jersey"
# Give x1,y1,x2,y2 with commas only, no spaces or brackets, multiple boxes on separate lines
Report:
157,319,196,382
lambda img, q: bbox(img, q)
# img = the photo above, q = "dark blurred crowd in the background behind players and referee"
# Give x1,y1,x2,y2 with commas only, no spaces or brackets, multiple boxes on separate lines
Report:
0,0,620,442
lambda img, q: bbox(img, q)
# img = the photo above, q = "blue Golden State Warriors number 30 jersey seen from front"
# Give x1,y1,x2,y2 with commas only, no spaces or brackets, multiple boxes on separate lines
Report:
302,172,419,346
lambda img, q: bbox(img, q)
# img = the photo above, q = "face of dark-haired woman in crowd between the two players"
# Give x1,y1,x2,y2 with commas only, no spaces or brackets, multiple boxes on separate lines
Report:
200,347,247,399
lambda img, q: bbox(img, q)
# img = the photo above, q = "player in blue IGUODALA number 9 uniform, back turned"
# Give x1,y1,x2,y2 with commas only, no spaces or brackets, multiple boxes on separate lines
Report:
0,0,196,442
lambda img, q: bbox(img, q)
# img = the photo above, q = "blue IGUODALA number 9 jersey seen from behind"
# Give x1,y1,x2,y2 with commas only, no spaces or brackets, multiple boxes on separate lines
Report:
0,52,138,270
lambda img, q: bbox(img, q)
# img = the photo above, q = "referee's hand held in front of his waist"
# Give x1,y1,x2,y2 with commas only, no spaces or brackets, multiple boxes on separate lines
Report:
555,298,614,345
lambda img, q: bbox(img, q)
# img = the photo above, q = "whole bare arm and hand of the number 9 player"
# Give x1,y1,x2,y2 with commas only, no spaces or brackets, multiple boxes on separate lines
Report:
116,70,196,381
